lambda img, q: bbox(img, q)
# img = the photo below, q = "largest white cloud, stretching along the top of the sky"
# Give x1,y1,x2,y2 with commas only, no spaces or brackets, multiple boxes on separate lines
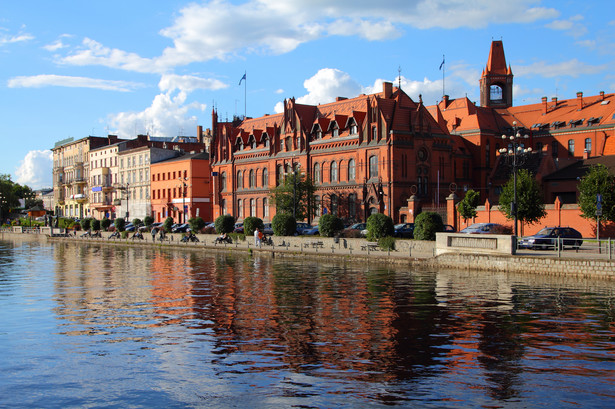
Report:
60,0,559,73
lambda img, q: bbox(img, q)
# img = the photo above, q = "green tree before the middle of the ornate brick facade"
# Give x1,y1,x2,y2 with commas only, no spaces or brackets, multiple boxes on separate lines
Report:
270,171,316,220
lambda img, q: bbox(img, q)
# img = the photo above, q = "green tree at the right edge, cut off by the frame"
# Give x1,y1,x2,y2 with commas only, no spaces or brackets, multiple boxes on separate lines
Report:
578,164,615,221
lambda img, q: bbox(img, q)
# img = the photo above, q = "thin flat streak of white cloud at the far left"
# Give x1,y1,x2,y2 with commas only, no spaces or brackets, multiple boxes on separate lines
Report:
7,75,141,92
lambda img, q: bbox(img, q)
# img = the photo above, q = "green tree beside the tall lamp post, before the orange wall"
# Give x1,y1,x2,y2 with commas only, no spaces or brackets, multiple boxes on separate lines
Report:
500,169,547,228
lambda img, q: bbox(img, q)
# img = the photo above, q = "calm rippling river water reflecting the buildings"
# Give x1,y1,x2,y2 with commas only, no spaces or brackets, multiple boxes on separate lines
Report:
0,237,615,408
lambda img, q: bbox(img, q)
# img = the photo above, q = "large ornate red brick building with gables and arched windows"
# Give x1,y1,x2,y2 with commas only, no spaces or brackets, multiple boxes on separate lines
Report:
210,83,470,221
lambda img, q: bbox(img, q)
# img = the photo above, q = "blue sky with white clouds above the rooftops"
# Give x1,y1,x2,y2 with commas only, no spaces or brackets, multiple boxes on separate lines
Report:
0,0,615,188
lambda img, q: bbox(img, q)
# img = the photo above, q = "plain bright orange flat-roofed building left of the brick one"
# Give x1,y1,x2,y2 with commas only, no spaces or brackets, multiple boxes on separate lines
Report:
150,152,211,223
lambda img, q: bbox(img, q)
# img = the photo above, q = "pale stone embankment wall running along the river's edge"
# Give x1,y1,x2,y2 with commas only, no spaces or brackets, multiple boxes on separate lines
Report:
0,229,615,279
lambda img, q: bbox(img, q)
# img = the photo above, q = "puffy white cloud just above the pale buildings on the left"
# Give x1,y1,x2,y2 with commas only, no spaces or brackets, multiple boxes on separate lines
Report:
109,92,206,138
